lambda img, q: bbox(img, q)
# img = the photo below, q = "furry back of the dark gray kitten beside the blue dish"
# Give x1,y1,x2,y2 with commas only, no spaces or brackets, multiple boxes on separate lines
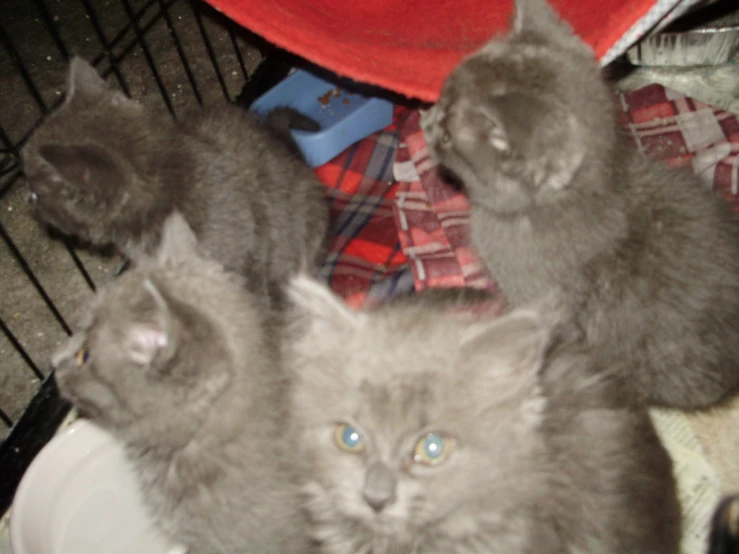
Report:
172,102,329,294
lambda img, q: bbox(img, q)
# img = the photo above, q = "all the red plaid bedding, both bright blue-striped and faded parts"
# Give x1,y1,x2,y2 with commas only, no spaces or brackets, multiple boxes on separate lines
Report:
316,85,739,307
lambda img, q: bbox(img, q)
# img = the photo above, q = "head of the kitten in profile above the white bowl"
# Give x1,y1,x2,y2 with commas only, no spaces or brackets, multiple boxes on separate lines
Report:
52,214,254,441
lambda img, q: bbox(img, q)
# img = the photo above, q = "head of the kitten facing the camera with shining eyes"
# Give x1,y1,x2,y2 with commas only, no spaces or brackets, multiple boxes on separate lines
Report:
285,277,549,552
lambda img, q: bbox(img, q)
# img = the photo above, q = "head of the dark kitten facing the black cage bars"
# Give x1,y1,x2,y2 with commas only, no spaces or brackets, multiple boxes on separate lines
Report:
21,58,145,244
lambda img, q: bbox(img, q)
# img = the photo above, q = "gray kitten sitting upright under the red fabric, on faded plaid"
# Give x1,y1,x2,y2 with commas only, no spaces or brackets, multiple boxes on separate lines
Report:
422,0,739,408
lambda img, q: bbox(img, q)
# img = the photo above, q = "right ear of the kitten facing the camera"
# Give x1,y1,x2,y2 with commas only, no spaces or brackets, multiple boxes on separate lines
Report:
461,309,551,399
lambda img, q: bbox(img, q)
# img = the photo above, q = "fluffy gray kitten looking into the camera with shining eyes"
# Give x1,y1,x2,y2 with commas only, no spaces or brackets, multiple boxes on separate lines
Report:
285,277,680,554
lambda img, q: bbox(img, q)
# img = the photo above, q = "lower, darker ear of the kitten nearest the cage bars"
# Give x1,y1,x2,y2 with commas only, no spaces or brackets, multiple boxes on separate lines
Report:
38,144,126,190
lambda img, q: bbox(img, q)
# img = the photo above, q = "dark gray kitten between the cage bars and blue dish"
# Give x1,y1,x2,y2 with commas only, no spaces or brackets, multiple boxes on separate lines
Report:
22,58,329,306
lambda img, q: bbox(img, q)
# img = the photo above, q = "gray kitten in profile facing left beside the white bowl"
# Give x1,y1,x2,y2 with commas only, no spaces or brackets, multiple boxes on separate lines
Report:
52,214,312,554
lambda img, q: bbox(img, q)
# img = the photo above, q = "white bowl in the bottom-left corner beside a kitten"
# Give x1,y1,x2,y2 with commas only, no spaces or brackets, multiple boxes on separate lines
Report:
10,420,185,554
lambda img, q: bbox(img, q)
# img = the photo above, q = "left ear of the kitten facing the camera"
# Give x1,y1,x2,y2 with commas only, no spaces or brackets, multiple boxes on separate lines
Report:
287,274,365,335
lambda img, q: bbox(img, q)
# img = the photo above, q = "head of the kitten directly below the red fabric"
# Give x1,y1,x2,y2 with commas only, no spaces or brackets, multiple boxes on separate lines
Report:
421,0,612,213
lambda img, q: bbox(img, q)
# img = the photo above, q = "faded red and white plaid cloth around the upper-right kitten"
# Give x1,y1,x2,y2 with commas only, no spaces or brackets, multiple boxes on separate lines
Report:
395,85,739,290
